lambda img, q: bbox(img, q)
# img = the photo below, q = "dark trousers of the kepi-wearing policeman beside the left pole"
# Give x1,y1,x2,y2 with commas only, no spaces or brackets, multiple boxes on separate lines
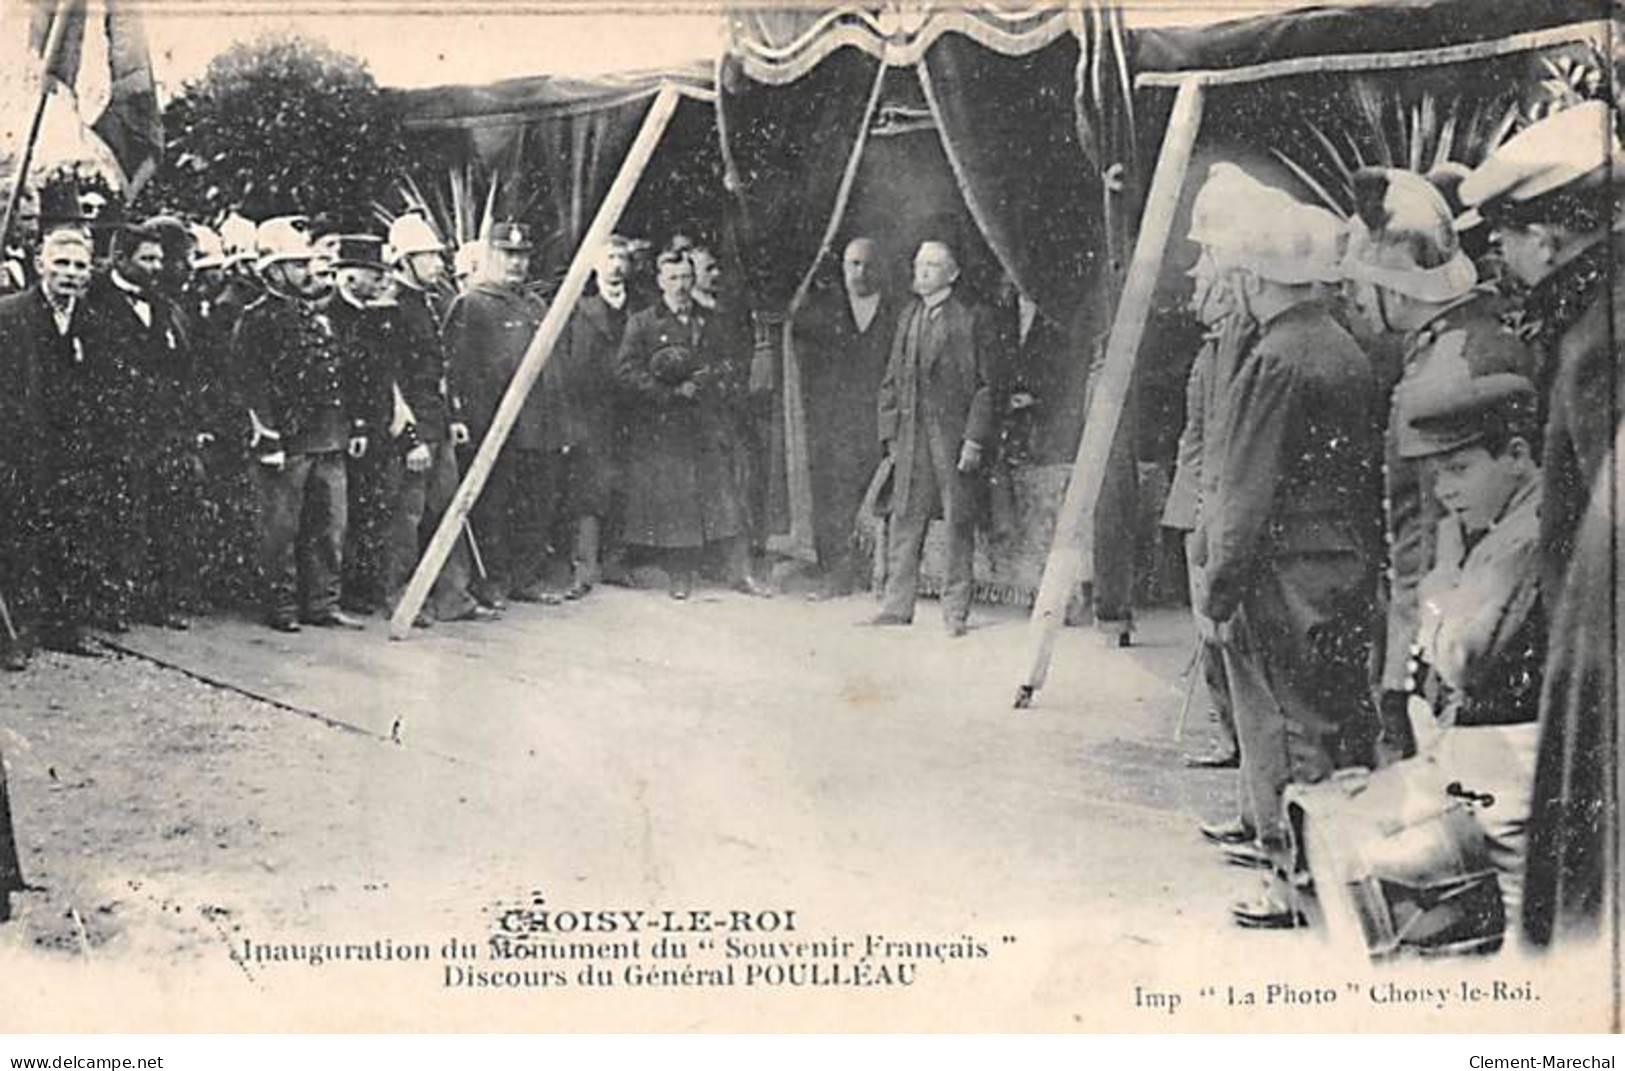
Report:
470,445,549,598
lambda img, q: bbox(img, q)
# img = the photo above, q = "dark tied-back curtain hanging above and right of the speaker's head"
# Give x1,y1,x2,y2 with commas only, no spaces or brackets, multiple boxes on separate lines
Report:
921,34,1100,323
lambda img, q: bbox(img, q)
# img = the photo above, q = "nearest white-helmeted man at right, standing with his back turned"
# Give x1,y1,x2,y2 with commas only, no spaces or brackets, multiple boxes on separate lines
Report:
1196,185,1378,926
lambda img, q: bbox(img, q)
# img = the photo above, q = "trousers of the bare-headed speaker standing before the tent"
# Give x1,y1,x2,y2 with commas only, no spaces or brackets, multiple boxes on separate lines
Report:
882,427,977,624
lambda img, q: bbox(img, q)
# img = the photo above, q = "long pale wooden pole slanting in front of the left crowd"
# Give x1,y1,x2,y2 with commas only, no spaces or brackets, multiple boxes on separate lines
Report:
390,85,683,640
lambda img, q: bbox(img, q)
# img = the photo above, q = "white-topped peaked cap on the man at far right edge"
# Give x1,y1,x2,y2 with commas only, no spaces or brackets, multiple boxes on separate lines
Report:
1456,101,1625,231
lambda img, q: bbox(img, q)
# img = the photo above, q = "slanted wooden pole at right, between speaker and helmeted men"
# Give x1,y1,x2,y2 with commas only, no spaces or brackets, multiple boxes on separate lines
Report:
1016,80,1203,710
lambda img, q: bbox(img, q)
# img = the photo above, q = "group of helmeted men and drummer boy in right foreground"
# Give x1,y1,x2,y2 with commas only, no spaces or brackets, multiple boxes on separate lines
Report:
1164,102,1620,954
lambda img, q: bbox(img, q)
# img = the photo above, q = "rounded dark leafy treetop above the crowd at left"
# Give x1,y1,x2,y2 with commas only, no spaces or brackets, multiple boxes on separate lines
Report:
140,33,406,219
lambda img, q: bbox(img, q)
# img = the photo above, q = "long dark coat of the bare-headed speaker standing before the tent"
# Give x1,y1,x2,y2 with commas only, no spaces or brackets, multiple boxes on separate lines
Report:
876,293,998,509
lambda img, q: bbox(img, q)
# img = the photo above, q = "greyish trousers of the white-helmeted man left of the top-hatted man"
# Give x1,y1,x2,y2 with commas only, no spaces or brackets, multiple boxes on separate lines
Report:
255,450,349,618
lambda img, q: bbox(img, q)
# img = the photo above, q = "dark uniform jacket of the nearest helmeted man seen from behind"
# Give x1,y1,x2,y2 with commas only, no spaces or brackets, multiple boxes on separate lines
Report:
1199,302,1380,621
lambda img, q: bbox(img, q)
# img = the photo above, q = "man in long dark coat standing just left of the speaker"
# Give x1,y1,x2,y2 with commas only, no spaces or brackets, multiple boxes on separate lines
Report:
796,236,897,598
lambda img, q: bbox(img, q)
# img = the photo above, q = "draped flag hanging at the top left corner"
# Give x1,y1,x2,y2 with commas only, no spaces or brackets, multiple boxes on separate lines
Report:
29,0,164,192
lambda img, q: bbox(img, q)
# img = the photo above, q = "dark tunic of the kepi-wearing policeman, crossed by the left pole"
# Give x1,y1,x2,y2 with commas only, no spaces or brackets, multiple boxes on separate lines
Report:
440,283,548,450
